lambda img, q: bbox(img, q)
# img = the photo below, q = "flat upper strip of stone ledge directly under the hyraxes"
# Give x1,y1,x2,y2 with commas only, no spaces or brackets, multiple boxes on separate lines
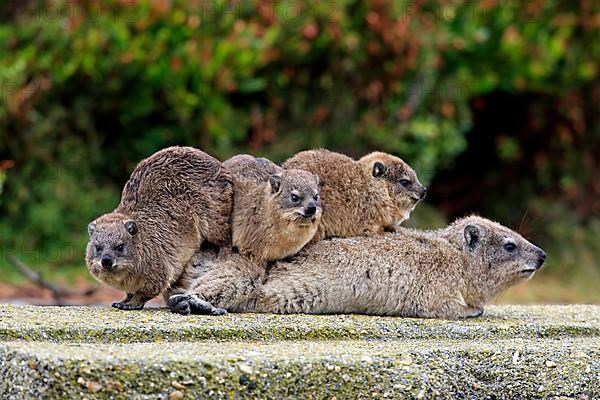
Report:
0,304,600,343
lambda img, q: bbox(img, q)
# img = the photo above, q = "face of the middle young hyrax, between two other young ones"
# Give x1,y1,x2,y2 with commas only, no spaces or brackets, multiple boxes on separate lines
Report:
269,169,321,227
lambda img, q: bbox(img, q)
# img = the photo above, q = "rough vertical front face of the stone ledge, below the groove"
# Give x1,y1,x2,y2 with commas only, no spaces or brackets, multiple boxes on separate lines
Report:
0,338,600,399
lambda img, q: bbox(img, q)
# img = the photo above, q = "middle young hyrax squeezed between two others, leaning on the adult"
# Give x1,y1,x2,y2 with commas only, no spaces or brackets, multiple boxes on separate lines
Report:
223,154,321,263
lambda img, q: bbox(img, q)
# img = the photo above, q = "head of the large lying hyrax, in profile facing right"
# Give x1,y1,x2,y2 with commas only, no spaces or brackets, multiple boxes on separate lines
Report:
449,216,546,288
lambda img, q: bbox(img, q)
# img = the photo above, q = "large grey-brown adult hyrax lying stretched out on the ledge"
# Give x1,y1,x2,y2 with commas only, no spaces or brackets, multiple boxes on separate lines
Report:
170,216,546,319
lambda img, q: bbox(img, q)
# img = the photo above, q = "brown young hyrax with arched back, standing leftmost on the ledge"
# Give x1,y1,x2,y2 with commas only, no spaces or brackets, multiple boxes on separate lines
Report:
86,147,233,310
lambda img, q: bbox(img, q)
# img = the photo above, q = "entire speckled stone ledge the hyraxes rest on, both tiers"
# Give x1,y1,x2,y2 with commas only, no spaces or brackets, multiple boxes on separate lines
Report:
0,305,600,399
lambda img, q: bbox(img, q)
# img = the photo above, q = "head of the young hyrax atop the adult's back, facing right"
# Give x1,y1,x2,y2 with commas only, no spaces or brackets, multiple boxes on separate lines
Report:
358,152,427,225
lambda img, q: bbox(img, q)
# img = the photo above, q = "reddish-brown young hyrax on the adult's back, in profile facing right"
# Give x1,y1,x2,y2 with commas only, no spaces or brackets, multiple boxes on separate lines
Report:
283,150,427,242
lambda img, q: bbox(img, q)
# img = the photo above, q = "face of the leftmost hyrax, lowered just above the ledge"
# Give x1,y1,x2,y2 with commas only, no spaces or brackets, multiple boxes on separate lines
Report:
86,214,138,284
